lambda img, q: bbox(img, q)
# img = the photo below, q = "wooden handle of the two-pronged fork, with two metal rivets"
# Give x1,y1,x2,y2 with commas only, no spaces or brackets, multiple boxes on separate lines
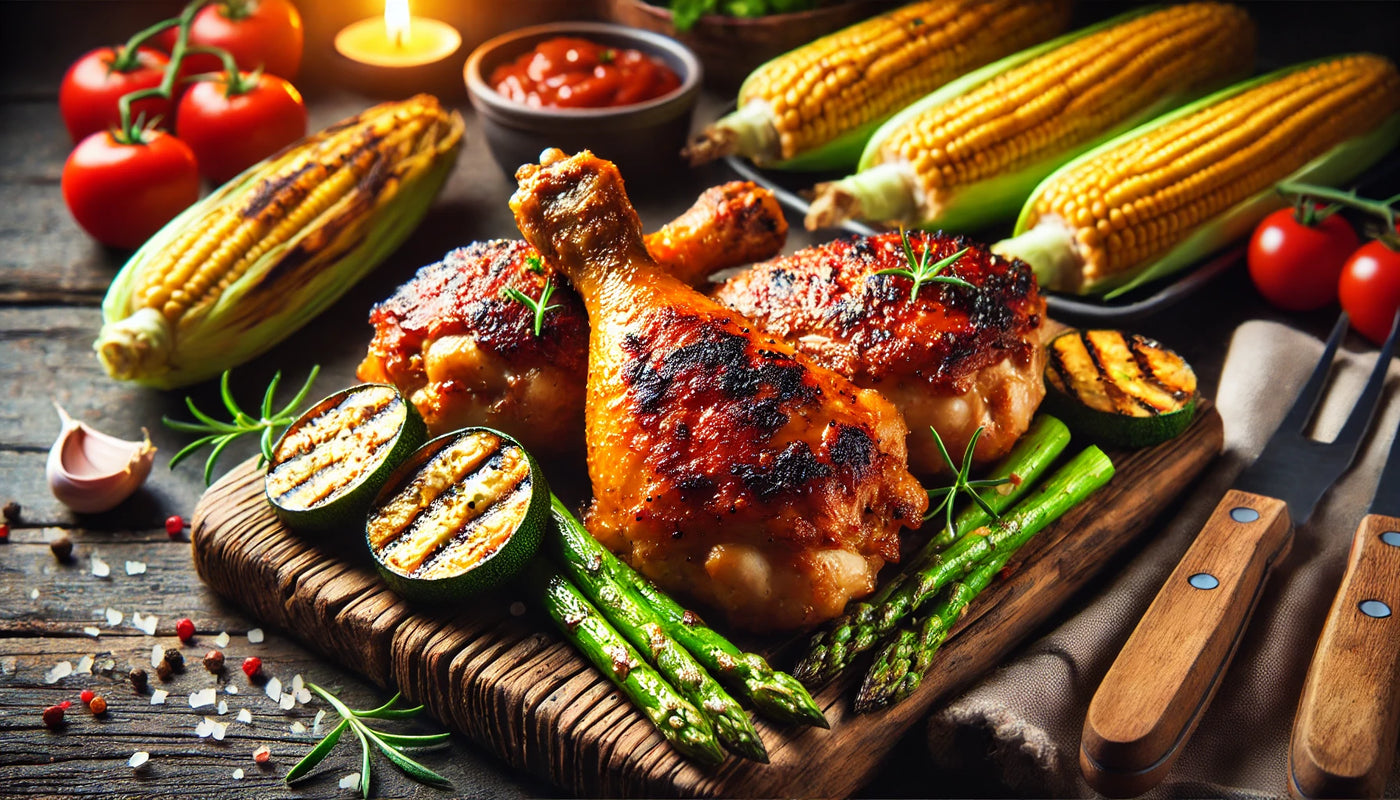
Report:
1079,489,1292,797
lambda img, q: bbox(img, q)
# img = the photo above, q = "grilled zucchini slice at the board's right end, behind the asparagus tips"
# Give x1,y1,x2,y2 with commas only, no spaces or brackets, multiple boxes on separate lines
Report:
1046,331,1197,447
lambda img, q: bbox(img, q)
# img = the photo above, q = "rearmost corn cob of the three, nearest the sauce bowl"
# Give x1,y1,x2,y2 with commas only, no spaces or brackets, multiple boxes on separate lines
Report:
686,0,1070,170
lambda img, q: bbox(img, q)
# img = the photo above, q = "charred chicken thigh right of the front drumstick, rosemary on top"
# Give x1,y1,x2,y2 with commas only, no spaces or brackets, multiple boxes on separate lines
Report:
715,231,1046,475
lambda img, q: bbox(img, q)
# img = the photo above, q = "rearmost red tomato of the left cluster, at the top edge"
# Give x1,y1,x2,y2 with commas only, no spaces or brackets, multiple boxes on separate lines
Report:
168,0,302,80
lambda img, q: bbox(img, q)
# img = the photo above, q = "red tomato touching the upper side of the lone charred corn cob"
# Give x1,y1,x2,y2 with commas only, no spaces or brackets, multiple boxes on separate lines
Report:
175,73,307,184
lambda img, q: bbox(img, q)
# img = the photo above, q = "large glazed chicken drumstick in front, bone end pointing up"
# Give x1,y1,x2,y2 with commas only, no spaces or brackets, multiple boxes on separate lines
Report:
511,150,928,630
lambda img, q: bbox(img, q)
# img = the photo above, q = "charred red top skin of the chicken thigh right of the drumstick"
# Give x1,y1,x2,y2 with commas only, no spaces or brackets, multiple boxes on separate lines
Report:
715,231,1044,391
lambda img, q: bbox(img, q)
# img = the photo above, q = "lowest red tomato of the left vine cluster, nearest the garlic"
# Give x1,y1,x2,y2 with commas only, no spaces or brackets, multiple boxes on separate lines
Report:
63,130,199,248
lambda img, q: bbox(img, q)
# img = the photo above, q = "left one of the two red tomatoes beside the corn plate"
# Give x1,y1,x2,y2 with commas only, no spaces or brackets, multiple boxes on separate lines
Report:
1247,209,1361,311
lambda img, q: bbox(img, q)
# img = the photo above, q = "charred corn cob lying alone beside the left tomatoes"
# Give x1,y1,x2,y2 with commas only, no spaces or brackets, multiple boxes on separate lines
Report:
94,95,463,388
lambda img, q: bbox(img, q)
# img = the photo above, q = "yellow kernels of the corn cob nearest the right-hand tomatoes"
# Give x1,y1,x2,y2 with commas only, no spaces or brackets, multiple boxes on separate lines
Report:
1025,55,1400,282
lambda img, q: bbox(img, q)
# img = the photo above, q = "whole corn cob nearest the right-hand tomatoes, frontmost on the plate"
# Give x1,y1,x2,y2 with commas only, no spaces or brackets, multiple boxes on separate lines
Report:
993,55,1400,297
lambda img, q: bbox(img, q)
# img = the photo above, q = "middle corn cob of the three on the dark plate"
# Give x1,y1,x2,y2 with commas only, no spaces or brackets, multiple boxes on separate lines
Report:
806,3,1254,230
